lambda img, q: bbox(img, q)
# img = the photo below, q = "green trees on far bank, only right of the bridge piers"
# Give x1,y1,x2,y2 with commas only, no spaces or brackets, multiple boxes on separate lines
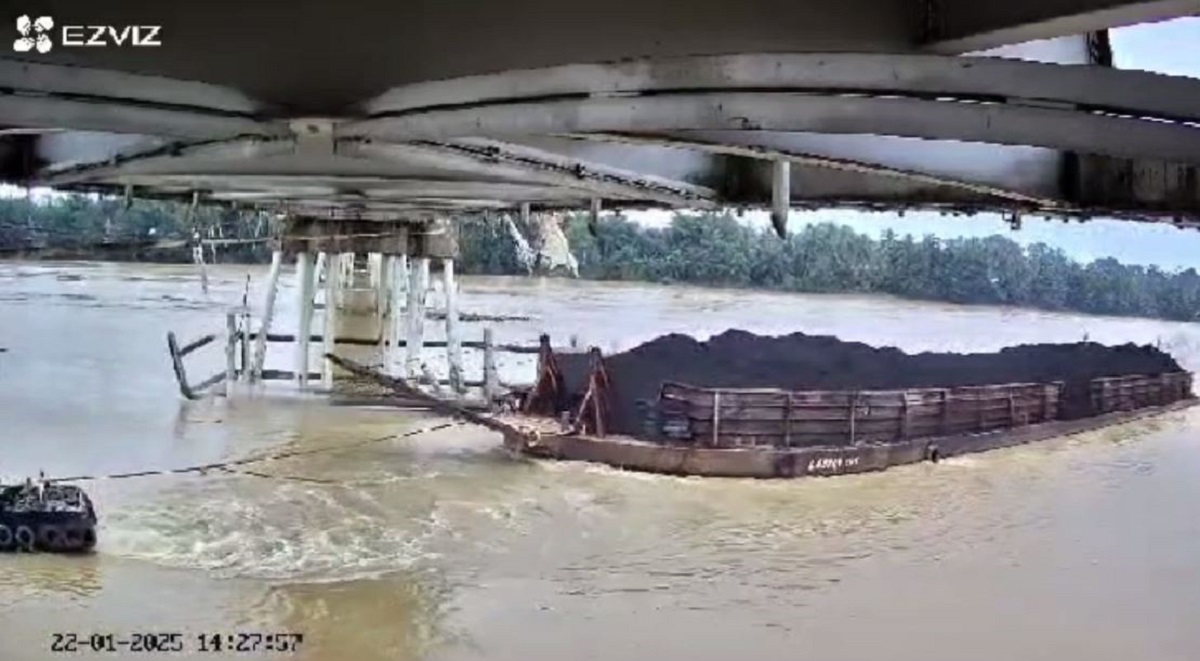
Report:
461,214,1200,320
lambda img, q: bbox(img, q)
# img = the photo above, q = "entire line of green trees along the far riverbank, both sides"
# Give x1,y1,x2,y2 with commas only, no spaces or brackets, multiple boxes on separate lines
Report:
0,196,1200,320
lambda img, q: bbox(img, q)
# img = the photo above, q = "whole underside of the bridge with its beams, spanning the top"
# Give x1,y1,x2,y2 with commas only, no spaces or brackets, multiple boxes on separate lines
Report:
0,0,1200,226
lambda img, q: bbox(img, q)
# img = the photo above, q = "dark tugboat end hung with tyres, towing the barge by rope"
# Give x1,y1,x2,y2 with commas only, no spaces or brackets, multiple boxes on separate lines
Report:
0,480,96,553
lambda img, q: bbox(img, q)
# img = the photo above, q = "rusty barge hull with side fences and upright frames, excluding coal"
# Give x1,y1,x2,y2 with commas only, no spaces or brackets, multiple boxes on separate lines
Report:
492,336,1198,477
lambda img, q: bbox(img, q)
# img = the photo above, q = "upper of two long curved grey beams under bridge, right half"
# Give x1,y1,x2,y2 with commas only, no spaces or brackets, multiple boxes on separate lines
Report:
362,53,1200,124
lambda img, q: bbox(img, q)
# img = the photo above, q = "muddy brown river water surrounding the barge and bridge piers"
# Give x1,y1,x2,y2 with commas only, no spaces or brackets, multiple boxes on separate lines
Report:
0,263,1200,661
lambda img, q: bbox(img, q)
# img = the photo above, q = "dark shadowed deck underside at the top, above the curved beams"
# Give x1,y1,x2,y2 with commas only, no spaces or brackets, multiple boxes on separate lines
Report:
0,0,916,116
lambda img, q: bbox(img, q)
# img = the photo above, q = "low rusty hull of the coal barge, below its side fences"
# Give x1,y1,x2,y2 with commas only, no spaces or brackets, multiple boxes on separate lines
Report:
504,397,1200,479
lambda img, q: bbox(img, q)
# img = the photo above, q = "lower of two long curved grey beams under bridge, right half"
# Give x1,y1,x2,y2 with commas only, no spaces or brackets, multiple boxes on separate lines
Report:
344,92,1200,163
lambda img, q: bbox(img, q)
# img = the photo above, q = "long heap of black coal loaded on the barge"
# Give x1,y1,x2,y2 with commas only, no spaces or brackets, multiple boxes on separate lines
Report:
558,330,1182,434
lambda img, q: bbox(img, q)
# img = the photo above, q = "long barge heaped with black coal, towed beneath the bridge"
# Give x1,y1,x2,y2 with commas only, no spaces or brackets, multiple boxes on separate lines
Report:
490,331,1196,479
